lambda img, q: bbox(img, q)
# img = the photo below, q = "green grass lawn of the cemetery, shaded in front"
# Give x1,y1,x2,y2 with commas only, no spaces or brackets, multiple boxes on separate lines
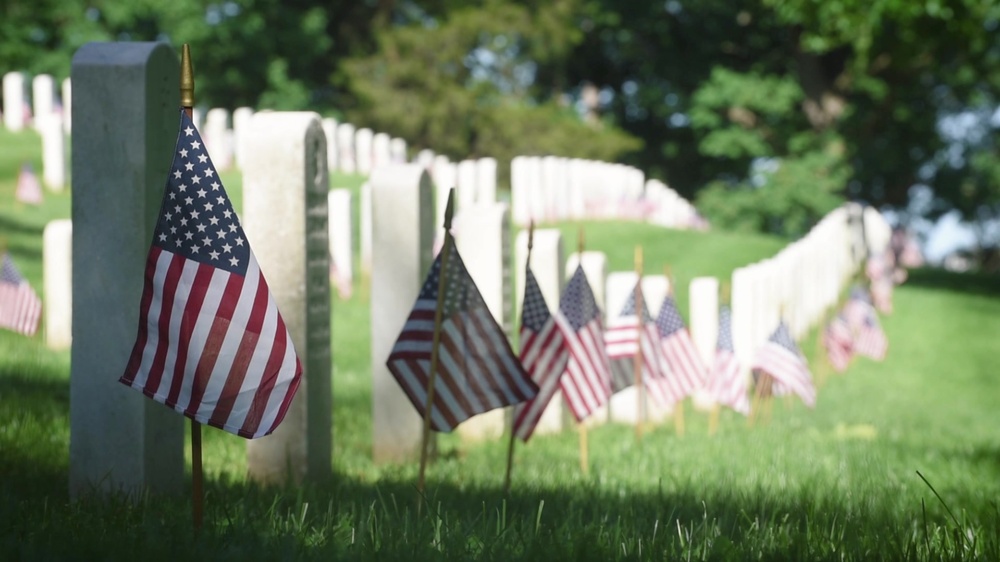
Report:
0,128,1000,560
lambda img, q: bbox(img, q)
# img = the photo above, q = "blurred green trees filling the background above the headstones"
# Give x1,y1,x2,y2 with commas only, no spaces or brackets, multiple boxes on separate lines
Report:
0,0,1000,244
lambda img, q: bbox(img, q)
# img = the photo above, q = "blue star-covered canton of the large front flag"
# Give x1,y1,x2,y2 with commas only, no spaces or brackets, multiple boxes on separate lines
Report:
153,110,250,276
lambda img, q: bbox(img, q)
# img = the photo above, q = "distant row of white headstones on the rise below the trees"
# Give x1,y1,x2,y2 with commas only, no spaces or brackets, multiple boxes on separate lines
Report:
511,156,707,228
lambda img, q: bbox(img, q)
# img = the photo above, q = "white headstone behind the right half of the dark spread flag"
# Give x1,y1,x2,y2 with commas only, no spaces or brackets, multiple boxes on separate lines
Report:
452,203,514,440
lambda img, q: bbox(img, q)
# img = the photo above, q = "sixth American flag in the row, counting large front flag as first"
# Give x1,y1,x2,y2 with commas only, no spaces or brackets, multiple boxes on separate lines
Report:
656,295,707,402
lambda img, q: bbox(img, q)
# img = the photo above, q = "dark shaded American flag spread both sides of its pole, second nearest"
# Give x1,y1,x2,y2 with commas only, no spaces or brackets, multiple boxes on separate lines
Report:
386,240,538,432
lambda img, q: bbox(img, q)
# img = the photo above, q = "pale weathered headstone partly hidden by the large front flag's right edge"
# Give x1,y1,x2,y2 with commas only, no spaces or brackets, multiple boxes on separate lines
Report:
243,112,333,483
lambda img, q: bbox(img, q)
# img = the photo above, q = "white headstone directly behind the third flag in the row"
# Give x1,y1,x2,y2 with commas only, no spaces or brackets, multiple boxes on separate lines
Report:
515,228,563,434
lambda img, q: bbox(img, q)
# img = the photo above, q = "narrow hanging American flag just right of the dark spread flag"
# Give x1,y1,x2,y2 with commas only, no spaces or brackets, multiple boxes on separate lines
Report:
514,266,569,441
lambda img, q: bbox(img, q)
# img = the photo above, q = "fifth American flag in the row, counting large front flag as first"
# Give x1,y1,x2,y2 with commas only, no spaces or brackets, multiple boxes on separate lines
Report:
604,282,675,407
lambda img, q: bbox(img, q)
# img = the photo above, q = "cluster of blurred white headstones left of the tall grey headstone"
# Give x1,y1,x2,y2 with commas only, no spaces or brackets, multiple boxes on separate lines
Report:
3,72,72,192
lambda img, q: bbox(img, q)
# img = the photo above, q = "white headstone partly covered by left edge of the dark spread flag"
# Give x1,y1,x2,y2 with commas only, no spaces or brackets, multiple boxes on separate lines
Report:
369,164,434,462
